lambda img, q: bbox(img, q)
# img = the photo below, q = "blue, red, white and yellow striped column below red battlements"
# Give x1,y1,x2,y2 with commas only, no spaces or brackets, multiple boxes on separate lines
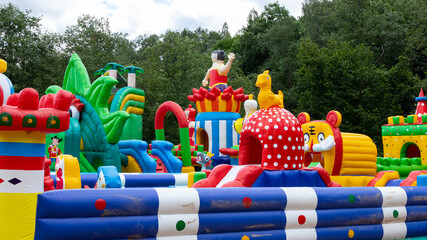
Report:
0,131,46,239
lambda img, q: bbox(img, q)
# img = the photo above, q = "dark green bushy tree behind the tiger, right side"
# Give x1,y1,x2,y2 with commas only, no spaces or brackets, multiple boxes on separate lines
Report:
295,39,416,146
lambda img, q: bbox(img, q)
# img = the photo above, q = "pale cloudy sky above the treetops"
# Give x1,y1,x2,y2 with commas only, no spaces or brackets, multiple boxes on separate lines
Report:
0,0,303,39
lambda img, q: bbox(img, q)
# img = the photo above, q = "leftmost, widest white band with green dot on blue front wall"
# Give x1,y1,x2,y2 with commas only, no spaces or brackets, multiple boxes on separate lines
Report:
155,188,200,240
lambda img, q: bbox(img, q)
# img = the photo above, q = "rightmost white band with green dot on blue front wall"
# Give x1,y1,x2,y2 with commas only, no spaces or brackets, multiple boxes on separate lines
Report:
378,187,407,239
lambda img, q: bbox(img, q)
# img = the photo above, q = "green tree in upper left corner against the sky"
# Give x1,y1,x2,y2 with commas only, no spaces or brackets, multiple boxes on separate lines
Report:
0,3,68,91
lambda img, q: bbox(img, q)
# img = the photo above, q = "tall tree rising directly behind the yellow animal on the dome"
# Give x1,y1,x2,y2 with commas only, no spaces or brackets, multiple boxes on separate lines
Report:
233,3,302,110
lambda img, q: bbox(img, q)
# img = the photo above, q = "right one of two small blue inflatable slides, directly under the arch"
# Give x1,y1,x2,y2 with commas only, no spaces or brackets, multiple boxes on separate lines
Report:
151,140,182,173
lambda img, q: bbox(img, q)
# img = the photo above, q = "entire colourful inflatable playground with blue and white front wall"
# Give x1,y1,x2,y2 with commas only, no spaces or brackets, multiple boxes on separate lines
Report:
0,51,427,240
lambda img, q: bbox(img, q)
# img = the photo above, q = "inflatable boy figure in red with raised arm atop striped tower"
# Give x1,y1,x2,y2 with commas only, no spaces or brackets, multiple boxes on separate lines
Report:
202,50,236,92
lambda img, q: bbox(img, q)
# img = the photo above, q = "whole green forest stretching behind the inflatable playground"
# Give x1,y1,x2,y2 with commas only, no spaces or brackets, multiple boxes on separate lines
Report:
0,0,427,153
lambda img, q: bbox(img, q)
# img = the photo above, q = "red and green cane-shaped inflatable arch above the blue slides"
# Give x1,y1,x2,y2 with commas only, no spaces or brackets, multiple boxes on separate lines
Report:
154,101,194,172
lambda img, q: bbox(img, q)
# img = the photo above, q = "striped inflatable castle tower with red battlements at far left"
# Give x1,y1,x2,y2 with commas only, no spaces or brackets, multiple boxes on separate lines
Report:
0,59,74,239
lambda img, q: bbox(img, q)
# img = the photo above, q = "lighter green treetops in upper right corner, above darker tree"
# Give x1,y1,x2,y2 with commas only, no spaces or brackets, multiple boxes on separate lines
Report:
300,0,427,79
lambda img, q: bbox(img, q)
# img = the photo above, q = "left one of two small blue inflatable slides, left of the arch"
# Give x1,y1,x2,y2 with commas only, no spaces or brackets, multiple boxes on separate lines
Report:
118,140,157,173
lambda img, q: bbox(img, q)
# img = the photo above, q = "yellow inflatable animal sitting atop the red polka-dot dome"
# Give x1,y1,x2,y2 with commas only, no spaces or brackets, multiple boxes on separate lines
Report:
255,70,283,109
